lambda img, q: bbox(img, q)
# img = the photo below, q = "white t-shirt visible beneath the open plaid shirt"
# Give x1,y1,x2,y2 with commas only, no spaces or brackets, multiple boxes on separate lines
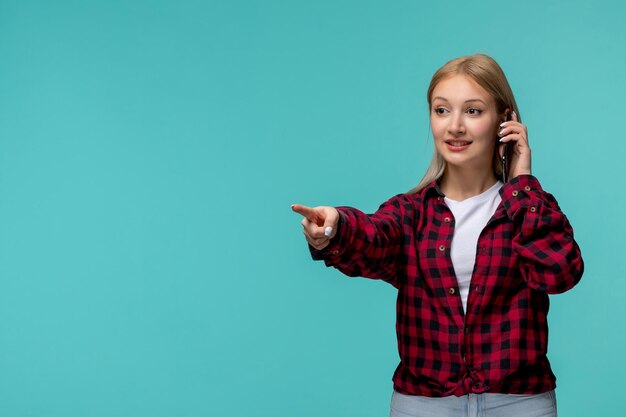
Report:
444,181,504,312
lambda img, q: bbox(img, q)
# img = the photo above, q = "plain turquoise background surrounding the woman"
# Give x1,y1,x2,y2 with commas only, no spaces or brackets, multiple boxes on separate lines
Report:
0,0,626,417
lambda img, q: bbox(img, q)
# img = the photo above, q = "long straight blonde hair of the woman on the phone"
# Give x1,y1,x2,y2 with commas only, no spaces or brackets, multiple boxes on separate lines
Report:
409,54,522,193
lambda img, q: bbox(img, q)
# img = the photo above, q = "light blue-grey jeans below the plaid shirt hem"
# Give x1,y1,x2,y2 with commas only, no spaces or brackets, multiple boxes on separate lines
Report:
389,391,556,417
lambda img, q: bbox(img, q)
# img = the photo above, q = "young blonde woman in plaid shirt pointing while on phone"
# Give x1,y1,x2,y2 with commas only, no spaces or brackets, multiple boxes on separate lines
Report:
292,54,583,417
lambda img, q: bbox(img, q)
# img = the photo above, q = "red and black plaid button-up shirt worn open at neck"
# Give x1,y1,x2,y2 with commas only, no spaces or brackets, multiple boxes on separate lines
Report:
311,175,583,397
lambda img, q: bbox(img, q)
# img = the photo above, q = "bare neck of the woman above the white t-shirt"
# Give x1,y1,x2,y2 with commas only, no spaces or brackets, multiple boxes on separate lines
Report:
439,165,498,201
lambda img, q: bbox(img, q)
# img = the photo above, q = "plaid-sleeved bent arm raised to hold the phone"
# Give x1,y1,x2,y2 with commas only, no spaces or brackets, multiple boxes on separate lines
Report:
501,175,584,294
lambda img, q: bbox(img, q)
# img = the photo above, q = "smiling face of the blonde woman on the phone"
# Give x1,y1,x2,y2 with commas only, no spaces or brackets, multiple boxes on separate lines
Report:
430,74,504,170
